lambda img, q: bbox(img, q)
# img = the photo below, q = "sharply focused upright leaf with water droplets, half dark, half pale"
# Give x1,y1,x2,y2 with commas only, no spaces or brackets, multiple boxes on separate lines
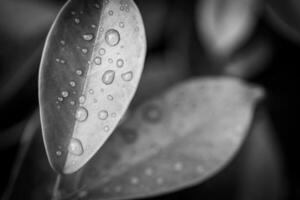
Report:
39,0,146,174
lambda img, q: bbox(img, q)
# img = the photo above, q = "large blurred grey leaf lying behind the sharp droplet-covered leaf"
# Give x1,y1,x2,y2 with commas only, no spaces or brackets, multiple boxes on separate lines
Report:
56,78,263,199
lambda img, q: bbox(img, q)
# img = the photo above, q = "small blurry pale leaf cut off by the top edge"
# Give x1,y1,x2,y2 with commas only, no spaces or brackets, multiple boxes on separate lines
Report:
196,0,260,57
